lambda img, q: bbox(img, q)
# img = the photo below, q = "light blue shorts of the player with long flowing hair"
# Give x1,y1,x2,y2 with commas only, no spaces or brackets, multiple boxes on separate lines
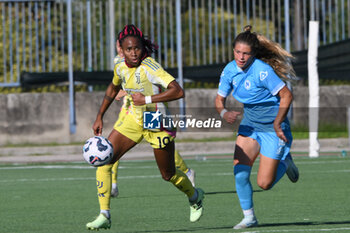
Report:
237,119,293,160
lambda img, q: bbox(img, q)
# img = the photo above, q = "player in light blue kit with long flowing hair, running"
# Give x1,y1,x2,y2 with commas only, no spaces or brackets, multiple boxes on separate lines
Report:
215,26,299,229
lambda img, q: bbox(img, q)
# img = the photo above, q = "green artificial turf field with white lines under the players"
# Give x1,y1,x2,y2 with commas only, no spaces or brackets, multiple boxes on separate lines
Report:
0,155,350,233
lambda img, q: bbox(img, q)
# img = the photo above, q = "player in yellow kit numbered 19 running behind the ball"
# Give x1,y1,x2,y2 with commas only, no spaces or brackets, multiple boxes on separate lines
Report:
86,25,204,230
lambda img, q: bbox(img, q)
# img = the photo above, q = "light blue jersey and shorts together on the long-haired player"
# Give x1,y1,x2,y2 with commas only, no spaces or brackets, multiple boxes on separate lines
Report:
218,58,293,160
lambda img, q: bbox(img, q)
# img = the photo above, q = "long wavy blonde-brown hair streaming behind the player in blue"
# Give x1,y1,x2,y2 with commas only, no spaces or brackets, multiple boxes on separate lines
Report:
233,25,296,80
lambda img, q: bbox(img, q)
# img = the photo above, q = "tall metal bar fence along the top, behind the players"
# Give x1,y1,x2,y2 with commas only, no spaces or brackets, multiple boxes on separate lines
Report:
0,0,350,86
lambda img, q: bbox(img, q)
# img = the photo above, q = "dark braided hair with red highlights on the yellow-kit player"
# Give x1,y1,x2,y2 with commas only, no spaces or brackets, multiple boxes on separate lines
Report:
118,24,158,60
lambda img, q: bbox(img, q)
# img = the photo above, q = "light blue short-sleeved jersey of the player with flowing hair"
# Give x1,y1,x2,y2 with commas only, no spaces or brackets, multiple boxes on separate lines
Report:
218,59,285,123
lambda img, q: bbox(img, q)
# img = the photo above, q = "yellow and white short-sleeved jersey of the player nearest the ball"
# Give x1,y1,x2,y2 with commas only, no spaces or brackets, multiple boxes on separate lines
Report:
112,57,175,125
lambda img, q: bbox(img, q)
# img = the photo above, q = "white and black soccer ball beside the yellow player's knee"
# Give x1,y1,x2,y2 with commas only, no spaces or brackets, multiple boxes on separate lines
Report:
83,136,113,167
